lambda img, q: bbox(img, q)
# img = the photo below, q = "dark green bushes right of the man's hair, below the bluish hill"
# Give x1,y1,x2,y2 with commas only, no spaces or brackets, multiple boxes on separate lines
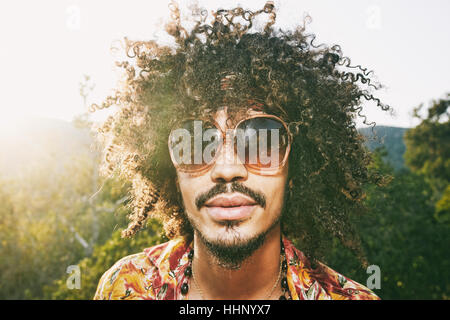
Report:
328,152,450,299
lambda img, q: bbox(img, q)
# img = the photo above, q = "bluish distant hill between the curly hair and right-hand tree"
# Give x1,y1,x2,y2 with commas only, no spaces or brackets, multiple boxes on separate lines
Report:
358,126,408,170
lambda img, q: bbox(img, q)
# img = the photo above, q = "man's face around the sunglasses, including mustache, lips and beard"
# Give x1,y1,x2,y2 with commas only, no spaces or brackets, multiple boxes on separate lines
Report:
177,108,288,264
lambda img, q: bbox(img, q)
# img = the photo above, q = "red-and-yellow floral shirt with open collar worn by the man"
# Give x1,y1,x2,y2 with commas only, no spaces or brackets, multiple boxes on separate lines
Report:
94,237,379,300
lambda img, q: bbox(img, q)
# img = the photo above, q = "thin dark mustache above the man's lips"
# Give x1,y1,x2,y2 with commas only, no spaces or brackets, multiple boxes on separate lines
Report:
195,181,266,210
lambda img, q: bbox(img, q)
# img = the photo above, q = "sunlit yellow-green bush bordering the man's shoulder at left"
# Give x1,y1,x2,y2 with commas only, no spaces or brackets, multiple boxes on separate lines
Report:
44,221,162,300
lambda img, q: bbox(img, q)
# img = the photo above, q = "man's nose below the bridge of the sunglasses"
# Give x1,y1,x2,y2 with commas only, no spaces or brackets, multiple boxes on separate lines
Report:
211,139,248,183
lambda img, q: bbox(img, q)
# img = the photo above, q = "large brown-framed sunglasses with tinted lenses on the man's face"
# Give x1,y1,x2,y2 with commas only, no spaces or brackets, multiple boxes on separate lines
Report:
168,114,294,175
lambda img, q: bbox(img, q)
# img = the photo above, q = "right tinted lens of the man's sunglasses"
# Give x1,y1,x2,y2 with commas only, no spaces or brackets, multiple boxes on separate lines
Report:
235,117,289,169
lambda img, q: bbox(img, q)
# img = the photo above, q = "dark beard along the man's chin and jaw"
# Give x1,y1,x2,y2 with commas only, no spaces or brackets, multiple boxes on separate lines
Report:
187,215,281,270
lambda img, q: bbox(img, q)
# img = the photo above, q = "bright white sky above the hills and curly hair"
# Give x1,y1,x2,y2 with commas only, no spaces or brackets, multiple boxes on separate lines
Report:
0,0,450,127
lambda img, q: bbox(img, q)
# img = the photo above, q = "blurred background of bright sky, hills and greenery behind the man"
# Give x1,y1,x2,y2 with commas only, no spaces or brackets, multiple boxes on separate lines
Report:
0,0,450,299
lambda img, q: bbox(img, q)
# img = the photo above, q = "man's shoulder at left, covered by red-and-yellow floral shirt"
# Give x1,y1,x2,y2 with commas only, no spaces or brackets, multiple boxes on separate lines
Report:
94,240,183,300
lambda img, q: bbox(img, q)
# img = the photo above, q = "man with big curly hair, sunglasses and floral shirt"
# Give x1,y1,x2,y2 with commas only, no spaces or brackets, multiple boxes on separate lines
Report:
95,2,389,300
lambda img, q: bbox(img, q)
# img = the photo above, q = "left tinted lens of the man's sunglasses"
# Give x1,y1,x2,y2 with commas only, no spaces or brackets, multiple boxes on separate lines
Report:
169,120,222,171
